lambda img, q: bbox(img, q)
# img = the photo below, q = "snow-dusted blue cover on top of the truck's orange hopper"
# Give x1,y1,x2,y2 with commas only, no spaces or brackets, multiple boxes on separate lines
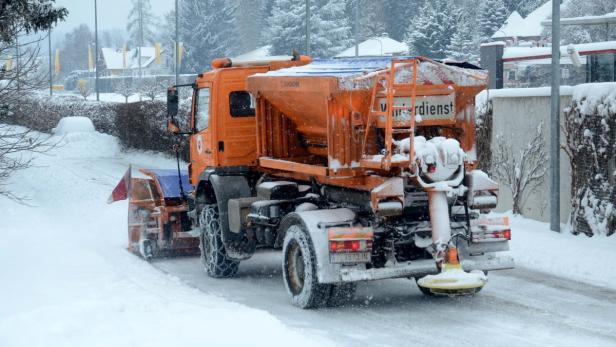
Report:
255,56,487,89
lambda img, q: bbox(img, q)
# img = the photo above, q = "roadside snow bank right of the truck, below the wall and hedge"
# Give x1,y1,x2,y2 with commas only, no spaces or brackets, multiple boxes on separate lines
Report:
507,214,616,289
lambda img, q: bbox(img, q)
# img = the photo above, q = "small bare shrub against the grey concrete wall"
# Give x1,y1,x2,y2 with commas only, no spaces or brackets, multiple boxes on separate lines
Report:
492,123,547,214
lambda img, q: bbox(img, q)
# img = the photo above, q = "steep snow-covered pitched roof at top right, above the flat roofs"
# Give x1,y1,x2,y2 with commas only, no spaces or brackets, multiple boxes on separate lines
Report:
492,0,567,39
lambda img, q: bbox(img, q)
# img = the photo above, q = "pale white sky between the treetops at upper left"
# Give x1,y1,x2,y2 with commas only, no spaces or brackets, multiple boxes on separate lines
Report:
55,0,175,34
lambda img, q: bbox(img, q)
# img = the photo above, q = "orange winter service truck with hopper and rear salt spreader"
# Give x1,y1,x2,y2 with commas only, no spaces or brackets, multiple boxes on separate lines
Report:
112,56,513,308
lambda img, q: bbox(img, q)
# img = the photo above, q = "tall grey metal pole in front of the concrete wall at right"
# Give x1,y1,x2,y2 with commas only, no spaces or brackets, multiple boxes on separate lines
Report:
550,0,560,232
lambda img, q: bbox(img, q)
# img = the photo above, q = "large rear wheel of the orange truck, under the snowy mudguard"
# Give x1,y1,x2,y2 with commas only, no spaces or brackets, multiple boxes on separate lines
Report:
282,224,332,309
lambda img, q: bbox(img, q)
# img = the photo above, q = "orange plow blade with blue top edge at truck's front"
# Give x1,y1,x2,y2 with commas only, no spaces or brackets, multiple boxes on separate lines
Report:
109,168,199,259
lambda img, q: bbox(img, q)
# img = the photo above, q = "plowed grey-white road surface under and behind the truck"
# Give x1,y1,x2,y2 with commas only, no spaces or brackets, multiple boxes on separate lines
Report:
153,251,616,346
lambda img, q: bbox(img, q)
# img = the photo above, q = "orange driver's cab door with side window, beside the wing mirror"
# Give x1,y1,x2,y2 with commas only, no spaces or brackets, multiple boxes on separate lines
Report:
190,83,217,172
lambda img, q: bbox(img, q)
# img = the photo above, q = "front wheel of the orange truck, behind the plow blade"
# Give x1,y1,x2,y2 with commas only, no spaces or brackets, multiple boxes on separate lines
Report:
199,204,240,278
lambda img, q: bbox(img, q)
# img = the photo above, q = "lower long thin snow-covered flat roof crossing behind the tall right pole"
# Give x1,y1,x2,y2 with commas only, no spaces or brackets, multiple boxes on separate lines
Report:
503,41,616,61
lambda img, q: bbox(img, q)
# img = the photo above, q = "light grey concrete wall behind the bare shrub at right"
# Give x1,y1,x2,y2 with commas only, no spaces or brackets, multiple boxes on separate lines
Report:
491,89,571,223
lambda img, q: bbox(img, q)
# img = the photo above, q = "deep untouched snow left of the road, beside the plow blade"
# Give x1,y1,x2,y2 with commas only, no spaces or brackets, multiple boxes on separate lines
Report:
0,127,331,347
